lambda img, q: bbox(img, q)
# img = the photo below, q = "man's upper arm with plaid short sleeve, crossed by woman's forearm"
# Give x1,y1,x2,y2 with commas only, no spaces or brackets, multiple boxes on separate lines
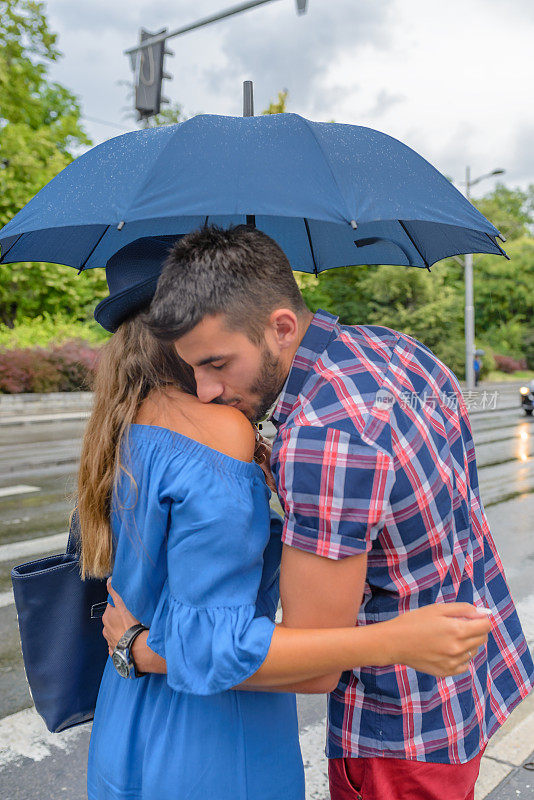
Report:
260,426,394,692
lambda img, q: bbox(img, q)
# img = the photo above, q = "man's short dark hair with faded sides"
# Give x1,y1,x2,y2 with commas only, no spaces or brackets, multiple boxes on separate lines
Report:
145,225,308,344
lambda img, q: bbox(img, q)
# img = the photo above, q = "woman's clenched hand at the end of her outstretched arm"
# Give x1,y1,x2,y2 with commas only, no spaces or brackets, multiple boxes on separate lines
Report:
387,603,491,678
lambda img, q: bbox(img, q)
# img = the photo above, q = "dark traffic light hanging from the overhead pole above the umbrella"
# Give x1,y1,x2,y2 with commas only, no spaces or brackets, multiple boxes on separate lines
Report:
135,28,172,119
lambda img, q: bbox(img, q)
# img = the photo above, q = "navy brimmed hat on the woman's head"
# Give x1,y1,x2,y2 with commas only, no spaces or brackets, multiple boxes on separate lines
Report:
94,236,182,333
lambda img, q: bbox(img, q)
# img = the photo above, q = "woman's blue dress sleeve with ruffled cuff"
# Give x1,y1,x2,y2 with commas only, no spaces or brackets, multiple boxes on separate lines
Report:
147,460,274,695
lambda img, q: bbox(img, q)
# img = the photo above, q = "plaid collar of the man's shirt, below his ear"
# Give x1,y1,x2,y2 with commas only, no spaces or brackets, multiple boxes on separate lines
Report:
271,308,339,427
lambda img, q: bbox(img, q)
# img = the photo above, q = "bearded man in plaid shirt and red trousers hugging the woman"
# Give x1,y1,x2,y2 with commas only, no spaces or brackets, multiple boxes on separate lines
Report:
105,227,534,800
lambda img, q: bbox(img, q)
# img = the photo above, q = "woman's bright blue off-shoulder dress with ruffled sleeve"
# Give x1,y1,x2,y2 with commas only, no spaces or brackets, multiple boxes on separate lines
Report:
87,425,304,800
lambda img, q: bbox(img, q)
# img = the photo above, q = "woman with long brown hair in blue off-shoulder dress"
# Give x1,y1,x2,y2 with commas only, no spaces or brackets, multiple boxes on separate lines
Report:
78,248,489,800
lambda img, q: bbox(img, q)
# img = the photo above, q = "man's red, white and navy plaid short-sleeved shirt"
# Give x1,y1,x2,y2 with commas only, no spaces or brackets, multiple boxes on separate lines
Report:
272,311,534,764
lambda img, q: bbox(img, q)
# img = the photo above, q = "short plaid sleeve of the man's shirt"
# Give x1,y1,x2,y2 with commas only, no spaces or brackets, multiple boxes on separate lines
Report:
274,426,395,559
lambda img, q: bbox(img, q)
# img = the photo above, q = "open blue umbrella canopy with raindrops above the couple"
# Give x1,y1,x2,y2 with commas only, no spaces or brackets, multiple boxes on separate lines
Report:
0,114,504,274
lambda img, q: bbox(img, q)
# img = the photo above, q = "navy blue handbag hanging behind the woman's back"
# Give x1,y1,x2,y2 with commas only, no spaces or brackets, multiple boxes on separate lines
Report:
11,512,108,733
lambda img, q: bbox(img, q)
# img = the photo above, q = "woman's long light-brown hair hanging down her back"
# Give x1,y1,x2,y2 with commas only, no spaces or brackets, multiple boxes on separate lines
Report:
77,315,195,578
